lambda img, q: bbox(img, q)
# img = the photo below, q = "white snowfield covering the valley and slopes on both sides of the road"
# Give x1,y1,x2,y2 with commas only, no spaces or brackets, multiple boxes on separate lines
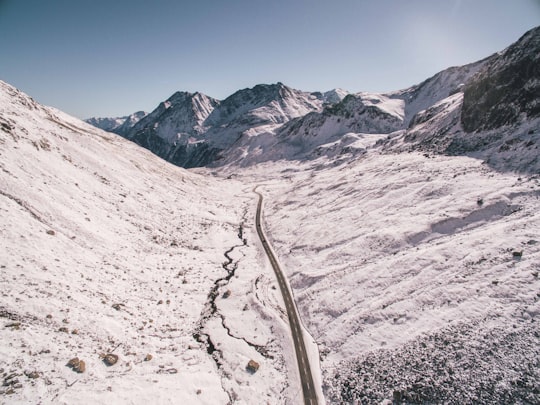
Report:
0,78,540,404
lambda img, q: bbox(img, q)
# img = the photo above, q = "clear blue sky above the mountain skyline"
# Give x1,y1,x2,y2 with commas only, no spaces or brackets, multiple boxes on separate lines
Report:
0,0,540,118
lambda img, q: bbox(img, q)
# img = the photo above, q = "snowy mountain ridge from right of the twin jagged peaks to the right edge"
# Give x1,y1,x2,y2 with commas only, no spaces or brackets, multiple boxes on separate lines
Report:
234,28,540,172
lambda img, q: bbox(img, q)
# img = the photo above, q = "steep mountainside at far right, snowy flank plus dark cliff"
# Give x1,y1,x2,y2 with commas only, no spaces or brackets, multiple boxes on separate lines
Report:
385,24,540,173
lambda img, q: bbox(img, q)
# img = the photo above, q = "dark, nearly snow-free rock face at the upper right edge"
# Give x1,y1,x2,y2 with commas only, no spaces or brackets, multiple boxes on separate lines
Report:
461,27,540,132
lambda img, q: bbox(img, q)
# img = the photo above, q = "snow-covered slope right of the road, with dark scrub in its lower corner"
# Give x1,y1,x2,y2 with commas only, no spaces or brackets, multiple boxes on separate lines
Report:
227,147,540,404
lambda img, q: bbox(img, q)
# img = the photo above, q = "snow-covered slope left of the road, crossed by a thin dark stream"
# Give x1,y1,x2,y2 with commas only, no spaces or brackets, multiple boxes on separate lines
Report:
0,82,299,404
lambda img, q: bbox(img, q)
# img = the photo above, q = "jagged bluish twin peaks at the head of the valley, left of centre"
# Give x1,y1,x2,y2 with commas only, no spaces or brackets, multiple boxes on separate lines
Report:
120,83,322,167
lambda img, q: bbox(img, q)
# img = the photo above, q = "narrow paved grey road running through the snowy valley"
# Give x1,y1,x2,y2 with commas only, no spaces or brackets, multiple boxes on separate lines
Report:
253,187,317,405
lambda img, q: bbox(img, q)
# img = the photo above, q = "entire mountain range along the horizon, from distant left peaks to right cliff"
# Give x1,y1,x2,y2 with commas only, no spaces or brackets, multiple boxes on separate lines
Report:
86,27,540,168
